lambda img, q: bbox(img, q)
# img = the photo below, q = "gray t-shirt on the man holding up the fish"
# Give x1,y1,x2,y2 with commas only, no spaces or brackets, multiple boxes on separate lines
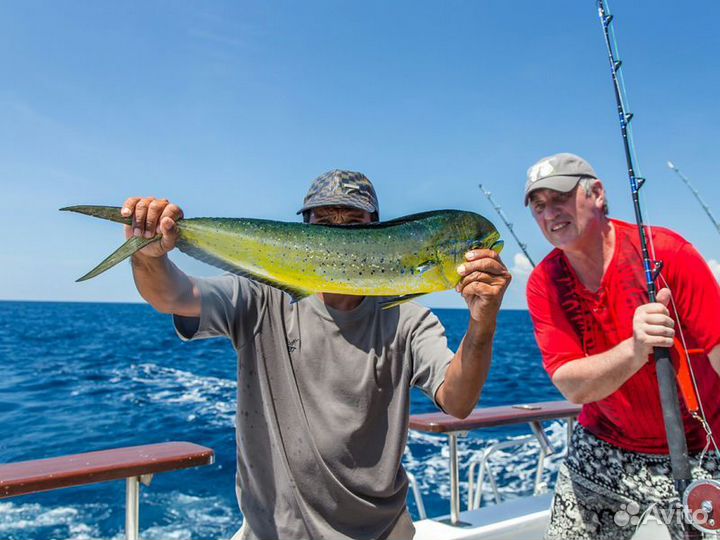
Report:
175,274,453,540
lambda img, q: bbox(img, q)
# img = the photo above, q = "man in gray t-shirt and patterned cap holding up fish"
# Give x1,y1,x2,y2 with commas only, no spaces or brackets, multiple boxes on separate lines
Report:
123,171,510,540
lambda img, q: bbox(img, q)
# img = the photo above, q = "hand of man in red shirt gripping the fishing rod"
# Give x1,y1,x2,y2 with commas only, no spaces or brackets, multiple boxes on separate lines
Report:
633,289,675,362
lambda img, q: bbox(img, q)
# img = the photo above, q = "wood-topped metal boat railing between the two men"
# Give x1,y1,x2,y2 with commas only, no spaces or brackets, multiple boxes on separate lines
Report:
410,401,581,525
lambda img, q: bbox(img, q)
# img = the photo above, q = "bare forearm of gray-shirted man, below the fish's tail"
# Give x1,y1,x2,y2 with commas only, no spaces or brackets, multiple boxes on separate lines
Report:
132,254,200,317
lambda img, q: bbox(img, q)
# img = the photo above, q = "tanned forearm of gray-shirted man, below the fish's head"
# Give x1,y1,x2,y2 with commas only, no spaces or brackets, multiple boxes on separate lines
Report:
437,318,495,418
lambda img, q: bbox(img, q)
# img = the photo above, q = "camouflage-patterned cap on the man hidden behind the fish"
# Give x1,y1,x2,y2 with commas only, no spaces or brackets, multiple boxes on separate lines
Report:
297,169,380,220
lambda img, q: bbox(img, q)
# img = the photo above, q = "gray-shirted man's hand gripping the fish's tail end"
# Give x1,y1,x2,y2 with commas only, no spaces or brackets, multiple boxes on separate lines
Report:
120,197,183,257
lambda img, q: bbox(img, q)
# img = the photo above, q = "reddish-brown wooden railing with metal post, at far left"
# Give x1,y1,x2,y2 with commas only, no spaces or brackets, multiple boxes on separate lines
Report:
0,442,215,540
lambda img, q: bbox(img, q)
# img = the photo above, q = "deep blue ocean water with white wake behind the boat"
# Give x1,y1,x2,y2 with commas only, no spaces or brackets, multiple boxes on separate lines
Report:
0,302,564,540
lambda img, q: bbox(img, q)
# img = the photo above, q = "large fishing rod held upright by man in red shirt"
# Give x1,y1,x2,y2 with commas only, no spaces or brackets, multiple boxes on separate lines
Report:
597,0,702,539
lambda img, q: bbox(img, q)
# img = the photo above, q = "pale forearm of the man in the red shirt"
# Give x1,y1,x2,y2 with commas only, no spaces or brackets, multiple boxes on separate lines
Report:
552,338,647,404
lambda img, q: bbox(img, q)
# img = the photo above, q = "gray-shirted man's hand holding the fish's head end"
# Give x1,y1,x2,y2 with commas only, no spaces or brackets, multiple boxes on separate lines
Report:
456,249,512,321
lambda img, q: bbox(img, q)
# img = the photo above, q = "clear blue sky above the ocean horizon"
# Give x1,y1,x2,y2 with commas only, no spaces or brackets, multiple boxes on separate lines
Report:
0,0,720,308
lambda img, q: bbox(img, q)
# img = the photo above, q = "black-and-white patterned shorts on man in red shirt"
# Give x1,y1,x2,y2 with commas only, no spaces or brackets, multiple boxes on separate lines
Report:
545,426,720,540
